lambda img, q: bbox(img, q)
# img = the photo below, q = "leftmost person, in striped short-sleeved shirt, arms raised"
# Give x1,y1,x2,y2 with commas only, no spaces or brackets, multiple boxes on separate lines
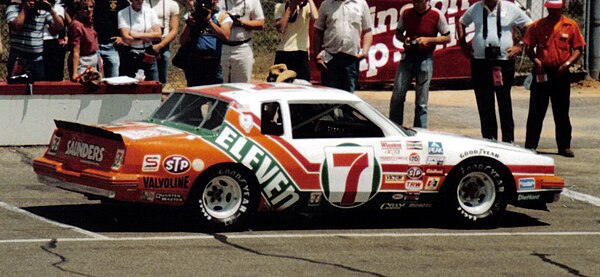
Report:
6,0,64,81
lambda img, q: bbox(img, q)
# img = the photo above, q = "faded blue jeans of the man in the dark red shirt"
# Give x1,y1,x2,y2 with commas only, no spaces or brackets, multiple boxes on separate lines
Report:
390,53,433,128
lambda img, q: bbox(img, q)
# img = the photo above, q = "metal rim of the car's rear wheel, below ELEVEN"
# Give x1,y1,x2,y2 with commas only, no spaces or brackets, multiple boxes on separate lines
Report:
202,176,242,219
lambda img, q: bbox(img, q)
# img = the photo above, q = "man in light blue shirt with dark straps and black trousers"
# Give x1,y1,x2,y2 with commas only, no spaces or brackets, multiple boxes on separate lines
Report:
456,0,531,142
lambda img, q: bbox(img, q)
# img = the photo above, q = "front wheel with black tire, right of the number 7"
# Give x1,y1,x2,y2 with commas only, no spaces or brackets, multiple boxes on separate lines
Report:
443,159,510,227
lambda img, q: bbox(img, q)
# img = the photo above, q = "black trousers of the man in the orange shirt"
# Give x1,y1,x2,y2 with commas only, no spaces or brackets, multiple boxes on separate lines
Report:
525,67,573,149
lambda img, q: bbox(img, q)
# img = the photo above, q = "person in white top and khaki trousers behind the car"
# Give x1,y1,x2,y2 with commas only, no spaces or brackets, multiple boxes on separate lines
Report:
218,0,265,83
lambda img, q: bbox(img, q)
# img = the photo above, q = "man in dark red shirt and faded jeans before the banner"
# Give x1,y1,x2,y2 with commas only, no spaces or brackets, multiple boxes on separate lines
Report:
390,0,450,128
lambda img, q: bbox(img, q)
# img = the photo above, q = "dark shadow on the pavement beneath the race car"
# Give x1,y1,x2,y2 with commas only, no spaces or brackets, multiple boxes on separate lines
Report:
25,204,548,233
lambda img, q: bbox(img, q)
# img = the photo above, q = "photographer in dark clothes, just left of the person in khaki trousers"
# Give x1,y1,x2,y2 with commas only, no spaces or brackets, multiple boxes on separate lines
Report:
178,0,233,87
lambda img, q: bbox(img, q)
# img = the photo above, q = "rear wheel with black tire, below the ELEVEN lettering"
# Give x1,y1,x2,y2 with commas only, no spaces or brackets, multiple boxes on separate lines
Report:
187,164,260,230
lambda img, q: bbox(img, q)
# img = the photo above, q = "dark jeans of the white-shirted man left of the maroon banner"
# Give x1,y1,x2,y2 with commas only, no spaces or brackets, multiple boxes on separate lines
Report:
321,53,359,93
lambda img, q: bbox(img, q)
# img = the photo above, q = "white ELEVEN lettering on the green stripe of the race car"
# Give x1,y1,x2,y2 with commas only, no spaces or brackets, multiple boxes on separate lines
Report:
207,124,300,210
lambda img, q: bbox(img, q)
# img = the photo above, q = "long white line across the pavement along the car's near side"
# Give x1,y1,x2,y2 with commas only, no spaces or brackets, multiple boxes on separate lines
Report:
0,232,600,244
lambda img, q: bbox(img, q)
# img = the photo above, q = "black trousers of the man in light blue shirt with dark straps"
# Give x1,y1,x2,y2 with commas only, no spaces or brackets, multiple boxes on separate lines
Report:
471,59,515,142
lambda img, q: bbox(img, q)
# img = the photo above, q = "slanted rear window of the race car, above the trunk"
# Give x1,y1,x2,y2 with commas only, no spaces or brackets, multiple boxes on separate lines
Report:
150,93,229,131
